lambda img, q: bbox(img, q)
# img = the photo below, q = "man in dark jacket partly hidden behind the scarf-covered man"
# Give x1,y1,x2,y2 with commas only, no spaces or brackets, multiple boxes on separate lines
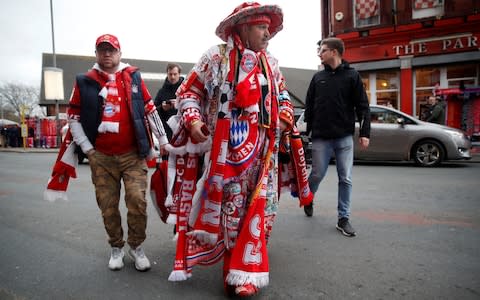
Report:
155,63,184,140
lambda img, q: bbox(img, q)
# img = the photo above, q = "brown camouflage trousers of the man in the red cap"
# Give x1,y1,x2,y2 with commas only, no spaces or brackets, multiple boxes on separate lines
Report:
89,151,148,249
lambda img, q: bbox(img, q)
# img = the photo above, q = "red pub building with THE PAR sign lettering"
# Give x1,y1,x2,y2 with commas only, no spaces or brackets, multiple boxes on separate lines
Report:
321,0,480,144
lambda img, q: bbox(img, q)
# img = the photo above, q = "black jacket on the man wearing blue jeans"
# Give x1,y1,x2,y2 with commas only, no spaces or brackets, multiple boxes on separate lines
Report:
305,61,370,139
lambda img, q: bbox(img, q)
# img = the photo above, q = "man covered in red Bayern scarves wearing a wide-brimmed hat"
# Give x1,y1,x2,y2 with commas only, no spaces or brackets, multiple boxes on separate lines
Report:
167,2,313,296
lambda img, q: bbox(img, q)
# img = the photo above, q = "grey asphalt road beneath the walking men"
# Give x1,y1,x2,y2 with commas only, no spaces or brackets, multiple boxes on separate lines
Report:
0,152,480,299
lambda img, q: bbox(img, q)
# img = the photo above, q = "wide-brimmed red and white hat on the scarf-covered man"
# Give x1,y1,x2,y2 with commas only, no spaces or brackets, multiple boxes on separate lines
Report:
215,2,283,41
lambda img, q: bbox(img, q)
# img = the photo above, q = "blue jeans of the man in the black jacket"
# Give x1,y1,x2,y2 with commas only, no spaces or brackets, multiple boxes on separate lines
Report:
308,135,353,219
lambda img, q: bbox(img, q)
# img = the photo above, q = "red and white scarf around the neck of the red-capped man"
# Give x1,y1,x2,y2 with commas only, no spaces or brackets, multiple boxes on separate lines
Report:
98,74,121,133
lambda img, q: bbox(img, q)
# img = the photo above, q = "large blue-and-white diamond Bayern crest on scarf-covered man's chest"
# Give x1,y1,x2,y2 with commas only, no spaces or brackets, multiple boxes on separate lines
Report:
227,109,258,165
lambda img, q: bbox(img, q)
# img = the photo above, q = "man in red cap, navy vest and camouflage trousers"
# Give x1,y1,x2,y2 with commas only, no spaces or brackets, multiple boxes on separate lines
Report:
67,34,168,271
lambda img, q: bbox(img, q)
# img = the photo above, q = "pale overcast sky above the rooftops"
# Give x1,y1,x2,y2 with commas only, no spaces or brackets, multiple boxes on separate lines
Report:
0,0,321,87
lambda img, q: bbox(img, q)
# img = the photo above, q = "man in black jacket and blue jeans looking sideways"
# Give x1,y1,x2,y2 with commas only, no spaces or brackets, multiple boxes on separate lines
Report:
304,38,370,236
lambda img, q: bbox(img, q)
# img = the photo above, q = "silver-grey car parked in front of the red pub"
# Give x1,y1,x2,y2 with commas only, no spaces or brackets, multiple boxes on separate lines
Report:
297,105,471,167
